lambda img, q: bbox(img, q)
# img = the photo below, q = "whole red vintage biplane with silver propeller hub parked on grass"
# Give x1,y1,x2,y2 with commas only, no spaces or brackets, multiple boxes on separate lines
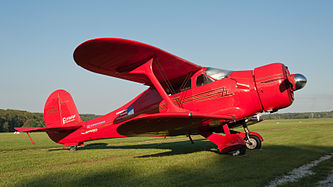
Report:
15,38,306,153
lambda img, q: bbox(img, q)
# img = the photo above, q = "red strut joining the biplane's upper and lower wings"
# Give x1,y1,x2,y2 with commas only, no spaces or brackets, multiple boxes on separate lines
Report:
130,58,188,112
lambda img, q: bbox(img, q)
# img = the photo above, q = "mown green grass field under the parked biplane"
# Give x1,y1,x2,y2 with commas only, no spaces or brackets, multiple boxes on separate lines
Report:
0,119,333,186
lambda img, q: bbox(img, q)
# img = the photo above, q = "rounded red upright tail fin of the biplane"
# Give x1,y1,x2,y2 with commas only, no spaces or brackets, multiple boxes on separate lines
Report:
44,90,82,128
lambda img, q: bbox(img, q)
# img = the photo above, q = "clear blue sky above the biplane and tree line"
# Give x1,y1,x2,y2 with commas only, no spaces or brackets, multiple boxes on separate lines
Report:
0,0,333,114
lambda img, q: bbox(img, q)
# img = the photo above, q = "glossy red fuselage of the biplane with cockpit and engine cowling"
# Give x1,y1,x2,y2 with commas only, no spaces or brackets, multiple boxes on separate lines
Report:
59,63,293,143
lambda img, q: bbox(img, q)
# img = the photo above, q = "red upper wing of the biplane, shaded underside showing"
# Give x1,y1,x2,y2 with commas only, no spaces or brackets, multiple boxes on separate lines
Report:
74,38,201,85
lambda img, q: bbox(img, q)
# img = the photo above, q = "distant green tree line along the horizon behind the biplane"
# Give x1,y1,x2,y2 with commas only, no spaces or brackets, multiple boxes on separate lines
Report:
0,109,333,132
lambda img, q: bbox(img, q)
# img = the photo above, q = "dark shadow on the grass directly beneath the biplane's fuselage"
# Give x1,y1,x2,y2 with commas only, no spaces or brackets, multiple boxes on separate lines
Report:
49,139,221,158
